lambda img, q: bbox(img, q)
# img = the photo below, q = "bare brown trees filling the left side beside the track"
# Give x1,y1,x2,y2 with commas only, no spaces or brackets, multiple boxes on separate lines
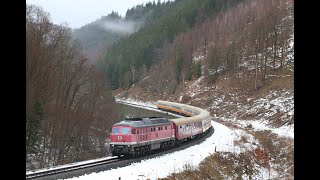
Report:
26,5,118,169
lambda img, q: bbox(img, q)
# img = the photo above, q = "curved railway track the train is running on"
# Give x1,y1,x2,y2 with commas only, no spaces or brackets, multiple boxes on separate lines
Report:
26,100,214,180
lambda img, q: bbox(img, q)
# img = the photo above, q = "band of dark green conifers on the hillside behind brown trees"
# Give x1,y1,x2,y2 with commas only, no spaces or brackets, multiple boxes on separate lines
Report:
99,0,241,89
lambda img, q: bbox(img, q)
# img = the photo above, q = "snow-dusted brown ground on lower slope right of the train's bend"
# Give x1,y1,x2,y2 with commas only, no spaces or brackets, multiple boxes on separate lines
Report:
207,89,294,122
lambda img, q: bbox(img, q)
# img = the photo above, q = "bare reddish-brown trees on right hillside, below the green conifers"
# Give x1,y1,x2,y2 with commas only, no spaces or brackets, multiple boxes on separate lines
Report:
138,0,293,94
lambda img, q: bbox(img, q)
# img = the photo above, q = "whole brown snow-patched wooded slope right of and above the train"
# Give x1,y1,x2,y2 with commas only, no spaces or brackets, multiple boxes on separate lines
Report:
116,0,294,126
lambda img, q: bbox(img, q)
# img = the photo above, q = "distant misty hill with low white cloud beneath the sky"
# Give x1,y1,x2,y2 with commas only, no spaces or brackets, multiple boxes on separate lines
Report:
73,1,178,63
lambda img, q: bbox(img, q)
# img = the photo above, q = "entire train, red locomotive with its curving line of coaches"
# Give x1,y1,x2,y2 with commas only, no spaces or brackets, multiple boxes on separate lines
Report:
109,100,213,157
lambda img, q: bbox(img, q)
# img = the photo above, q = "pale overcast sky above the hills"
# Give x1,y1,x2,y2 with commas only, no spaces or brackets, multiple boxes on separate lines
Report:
26,0,167,28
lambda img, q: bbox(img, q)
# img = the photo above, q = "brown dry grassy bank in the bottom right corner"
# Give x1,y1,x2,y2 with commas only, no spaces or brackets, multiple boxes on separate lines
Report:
162,131,294,180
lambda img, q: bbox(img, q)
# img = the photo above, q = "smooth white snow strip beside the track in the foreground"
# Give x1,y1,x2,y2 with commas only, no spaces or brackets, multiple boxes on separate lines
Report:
63,121,248,180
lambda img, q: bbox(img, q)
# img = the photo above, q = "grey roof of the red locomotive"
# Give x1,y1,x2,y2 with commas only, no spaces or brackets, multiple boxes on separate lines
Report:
114,117,172,127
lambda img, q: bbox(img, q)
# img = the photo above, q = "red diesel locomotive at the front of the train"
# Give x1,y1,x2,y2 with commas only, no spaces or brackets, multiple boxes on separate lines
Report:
110,117,175,157
